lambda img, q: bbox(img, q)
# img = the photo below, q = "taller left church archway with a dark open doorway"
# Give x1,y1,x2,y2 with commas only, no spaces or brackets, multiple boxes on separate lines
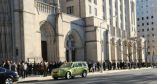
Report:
40,21,57,61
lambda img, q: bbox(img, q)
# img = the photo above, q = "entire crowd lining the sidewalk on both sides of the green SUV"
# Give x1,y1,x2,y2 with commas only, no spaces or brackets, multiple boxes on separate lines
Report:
0,60,155,78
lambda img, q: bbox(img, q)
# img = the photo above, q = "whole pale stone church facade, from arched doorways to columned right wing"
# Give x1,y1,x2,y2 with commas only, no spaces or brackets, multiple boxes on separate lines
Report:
0,0,144,62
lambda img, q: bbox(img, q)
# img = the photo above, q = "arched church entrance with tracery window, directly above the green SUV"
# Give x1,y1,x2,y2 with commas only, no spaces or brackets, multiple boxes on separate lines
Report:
65,30,83,61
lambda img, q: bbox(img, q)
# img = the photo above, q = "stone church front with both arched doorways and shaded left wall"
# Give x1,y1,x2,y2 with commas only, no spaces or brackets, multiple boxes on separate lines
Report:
0,0,85,62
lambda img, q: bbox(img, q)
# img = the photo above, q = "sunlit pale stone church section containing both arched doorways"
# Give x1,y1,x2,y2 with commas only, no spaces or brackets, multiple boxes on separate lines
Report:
15,0,87,62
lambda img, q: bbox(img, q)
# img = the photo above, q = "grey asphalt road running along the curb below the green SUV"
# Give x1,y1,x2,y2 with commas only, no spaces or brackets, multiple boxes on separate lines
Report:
19,68,157,84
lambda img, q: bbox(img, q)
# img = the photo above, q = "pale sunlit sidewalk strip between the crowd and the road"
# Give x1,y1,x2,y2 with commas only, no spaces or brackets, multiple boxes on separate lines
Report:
18,67,151,83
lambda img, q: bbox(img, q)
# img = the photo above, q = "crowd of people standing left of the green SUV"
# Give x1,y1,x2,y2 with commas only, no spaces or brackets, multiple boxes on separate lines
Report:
1,61,63,78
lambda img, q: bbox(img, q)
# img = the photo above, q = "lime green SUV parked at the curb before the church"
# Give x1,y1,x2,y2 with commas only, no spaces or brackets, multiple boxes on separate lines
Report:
51,62,88,80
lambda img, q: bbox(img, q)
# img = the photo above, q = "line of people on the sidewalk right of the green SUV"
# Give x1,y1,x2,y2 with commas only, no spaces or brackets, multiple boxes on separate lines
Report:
88,61,152,72
